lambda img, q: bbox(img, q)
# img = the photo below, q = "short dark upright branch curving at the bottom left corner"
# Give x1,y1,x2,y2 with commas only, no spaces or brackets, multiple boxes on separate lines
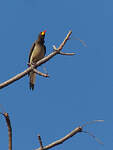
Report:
1,112,12,150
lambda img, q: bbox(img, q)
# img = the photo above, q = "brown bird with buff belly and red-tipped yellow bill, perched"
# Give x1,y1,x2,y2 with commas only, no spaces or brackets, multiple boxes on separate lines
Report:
28,30,46,90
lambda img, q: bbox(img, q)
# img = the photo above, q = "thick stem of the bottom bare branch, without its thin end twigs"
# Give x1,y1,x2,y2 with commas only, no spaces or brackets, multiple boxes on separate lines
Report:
36,127,82,150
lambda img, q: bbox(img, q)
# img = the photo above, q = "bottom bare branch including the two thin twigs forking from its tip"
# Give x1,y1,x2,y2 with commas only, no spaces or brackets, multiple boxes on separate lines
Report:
36,120,103,150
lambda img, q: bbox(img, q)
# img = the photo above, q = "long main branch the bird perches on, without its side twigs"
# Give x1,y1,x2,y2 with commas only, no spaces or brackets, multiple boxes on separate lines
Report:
0,31,72,89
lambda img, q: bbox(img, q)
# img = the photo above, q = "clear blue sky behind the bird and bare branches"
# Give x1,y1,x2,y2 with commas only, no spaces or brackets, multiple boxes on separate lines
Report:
0,0,113,150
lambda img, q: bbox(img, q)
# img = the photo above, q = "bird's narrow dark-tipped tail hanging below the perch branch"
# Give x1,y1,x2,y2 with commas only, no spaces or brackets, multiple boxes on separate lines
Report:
29,71,36,90
